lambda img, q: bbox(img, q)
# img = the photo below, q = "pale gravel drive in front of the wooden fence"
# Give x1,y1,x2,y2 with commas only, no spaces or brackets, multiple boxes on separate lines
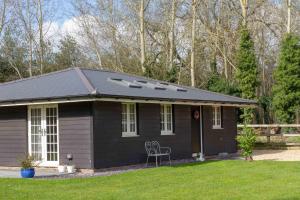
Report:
253,150,300,161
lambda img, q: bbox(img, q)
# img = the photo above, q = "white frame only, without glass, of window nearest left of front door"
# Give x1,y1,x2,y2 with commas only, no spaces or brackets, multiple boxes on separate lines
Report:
160,104,174,135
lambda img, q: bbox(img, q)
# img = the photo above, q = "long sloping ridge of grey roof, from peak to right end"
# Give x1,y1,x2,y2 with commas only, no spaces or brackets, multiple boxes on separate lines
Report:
82,68,256,102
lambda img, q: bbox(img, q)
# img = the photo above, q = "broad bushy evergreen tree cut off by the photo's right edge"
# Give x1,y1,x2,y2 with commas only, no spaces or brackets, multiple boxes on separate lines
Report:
273,34,300,123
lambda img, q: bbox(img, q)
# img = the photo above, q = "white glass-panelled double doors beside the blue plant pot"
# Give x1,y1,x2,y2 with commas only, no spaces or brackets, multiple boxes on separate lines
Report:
28,105,59,166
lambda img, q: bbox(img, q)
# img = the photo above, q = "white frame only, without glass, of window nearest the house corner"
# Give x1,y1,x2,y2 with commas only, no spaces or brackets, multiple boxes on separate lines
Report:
121,103,138,137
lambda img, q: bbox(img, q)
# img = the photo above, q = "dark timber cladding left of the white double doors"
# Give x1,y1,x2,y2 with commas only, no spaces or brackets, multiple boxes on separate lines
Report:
0,106,27,166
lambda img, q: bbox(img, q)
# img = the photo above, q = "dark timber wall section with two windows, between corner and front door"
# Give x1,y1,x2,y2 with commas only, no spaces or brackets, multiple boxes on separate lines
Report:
93,102,191,168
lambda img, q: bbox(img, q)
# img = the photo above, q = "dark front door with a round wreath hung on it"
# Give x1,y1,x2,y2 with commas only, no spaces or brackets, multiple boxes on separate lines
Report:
191,106,201,153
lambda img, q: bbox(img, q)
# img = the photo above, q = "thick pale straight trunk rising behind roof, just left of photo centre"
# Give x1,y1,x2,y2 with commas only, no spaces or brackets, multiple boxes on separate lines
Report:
140,0,146,73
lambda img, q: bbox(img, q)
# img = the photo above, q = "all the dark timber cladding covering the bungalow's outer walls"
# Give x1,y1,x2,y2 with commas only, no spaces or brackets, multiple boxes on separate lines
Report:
0,101,237,168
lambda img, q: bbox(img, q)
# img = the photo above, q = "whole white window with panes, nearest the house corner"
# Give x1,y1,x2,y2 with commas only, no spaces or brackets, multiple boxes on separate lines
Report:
122,103,137,137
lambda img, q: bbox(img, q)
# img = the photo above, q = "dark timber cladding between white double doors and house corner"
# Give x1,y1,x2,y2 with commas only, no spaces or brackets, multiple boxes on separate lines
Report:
58,102,93,168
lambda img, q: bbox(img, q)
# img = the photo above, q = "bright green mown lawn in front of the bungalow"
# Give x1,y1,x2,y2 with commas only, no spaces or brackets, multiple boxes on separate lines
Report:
0,160,300,200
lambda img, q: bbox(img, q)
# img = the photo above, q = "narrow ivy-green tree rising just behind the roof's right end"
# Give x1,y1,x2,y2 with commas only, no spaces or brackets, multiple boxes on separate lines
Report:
236,27,259,123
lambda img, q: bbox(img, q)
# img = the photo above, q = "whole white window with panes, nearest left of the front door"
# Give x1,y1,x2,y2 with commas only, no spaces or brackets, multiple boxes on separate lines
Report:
160,104,173,135
